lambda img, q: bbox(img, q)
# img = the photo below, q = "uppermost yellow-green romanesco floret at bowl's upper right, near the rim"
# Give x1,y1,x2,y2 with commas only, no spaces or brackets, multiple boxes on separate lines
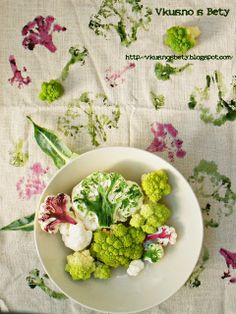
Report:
142,170,171,202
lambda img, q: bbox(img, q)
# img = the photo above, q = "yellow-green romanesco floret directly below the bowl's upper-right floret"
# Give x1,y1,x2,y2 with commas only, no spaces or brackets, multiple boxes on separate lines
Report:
130,202,171,234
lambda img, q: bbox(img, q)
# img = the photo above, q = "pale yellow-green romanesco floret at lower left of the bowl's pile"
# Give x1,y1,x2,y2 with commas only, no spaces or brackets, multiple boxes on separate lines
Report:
65,250,95,280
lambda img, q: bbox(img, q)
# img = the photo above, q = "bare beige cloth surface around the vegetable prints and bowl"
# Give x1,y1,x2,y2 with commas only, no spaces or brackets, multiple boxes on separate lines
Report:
0,0,236,314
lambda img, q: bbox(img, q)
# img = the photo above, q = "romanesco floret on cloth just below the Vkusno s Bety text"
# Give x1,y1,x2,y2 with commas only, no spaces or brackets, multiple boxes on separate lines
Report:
165,26,201,54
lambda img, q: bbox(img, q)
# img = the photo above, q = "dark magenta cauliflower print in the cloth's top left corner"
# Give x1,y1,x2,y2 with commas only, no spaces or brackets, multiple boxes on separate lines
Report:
21,16,66,52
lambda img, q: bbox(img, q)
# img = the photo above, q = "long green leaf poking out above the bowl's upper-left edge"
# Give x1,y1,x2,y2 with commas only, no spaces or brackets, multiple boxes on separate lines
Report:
27,116,78,168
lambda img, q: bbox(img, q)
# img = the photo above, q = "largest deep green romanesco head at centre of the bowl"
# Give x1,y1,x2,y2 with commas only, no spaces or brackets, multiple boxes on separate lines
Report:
90,224,146,267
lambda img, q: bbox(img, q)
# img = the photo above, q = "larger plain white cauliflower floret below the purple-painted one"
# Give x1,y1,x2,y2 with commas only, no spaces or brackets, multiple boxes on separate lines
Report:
60,221,93,251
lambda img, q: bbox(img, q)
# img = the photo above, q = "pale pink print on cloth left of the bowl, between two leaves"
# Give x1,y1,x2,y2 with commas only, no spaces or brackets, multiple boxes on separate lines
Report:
16,162,49,200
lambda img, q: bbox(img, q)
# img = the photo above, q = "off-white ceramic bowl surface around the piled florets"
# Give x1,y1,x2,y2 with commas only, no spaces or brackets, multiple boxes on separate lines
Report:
34,147,203,313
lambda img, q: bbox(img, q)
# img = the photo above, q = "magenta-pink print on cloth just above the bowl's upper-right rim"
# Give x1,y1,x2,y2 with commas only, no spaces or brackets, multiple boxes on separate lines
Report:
147,122,186,162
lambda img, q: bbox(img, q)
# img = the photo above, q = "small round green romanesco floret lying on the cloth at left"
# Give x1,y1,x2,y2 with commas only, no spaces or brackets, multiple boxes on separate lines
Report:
39,80,64,103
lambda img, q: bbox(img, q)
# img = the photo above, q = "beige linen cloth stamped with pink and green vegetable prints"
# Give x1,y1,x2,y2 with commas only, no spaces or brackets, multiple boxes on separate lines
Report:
0,0,236,314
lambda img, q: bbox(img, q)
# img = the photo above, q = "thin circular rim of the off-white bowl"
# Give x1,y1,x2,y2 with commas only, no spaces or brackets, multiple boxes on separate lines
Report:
34,146,204,314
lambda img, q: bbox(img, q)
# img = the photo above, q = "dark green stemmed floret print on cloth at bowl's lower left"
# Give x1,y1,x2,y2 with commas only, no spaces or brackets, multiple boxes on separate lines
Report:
26,269,67,300
